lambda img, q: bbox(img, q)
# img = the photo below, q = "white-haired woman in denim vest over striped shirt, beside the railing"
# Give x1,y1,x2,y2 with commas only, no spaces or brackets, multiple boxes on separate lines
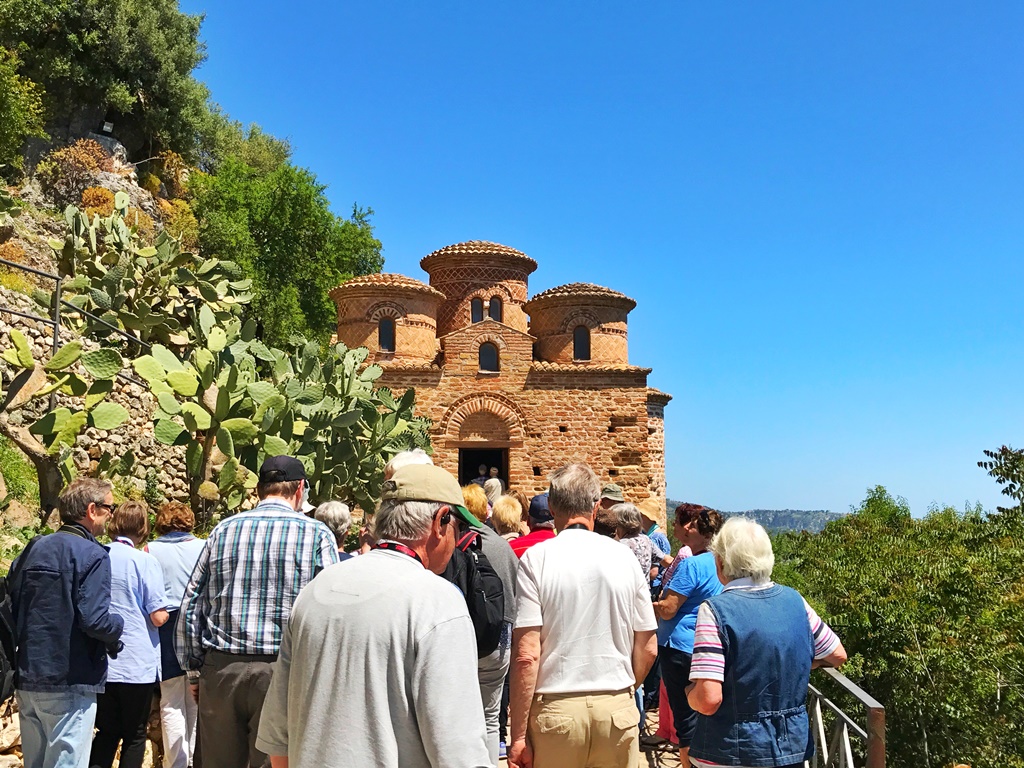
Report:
687,517,846,768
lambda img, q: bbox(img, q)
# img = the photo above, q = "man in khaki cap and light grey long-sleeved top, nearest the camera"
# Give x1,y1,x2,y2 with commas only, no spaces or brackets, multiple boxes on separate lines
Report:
257,465,492,768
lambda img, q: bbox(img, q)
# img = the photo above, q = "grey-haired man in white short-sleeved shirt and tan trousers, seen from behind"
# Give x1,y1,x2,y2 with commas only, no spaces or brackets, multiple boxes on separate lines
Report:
509,464,657,768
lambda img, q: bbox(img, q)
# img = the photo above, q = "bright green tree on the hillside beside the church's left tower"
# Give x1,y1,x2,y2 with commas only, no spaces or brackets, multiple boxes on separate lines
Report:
189,158,383,346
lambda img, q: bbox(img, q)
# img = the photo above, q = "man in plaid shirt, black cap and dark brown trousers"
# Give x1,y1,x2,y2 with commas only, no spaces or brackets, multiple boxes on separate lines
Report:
174,456,339,768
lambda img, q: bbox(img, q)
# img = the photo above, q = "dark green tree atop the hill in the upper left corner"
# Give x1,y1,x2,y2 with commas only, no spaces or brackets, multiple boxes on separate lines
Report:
0,0,210,160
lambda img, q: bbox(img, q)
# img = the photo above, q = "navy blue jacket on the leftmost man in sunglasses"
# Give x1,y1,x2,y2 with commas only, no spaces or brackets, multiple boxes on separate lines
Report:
7,523,124,693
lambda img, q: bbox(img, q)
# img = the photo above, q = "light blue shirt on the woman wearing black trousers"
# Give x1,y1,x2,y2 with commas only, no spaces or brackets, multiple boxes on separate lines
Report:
106,539,168,683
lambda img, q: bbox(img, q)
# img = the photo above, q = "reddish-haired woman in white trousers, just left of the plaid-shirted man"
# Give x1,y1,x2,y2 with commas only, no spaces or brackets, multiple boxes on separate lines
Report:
150,502,206,768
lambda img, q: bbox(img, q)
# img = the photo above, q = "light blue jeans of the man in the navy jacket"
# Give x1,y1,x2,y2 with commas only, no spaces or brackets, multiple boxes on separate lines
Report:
17,690,96,768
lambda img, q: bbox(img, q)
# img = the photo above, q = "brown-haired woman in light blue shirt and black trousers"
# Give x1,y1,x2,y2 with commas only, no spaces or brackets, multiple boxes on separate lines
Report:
89,501,168,768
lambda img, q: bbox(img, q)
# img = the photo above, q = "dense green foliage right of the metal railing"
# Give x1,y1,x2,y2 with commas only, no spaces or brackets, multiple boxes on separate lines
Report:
774,486,1024,768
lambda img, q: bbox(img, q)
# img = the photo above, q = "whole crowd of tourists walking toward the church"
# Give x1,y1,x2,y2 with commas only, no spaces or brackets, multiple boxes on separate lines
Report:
8,451,846,768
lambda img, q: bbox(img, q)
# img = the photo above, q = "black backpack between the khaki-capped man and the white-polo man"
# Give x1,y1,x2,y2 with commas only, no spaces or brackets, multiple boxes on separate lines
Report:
443,530,505,658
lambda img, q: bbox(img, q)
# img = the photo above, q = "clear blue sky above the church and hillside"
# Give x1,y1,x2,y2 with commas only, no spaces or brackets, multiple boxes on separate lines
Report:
182,0,1024,514
